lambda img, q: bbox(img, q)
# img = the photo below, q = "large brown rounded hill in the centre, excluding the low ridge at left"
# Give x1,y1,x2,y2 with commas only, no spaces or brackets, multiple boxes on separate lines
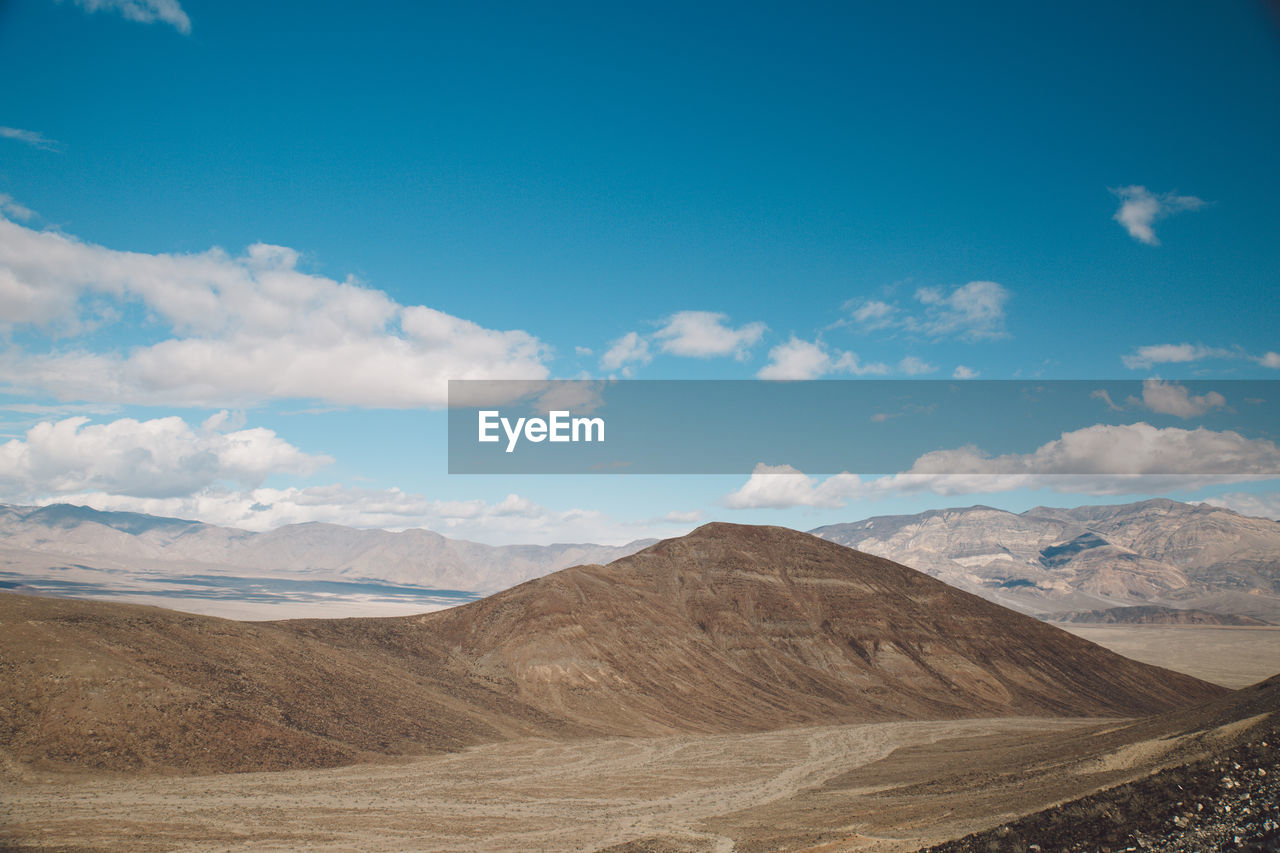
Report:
396,524,1221,733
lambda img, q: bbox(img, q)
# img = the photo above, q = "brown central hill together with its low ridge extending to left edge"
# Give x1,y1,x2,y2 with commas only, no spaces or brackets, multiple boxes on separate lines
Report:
0,524,1224,772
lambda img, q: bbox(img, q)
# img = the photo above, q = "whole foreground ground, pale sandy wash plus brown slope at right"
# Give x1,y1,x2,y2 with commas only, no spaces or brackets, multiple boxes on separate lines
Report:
0,679,1280,853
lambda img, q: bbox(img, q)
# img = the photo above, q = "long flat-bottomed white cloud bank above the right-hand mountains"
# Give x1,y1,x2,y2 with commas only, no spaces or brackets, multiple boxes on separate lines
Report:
723,423,1280,508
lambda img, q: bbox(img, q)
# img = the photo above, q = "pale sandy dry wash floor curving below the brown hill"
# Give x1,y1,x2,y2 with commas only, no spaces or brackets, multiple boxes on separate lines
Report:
0,720,1096,850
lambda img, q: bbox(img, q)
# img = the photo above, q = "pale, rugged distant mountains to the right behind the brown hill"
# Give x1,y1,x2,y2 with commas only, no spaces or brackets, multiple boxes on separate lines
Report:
812,500,1280,622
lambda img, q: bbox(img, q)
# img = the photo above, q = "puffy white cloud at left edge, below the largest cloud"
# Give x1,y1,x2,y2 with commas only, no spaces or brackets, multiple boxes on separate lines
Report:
0,414,332,501
